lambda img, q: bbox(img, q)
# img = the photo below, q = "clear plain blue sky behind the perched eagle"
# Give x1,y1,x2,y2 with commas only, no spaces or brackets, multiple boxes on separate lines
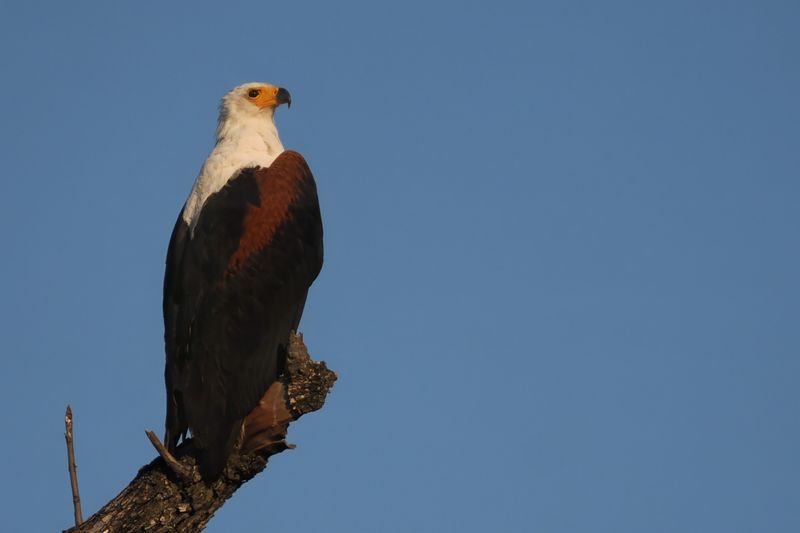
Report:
0,1,800,533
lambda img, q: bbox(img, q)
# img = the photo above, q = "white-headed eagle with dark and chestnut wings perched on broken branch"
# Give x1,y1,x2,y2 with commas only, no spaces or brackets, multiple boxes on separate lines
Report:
163,83,323,481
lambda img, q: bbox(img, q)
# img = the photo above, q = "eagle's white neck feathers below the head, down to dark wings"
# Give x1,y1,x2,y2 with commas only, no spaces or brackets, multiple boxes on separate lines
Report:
183,111,283,232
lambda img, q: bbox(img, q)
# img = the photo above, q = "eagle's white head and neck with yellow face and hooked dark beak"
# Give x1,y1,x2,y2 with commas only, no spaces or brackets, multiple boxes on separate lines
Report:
183,82,292,229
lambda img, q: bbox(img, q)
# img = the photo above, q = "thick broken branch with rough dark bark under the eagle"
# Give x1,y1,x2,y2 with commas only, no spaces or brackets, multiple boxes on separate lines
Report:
65,335,336,533
